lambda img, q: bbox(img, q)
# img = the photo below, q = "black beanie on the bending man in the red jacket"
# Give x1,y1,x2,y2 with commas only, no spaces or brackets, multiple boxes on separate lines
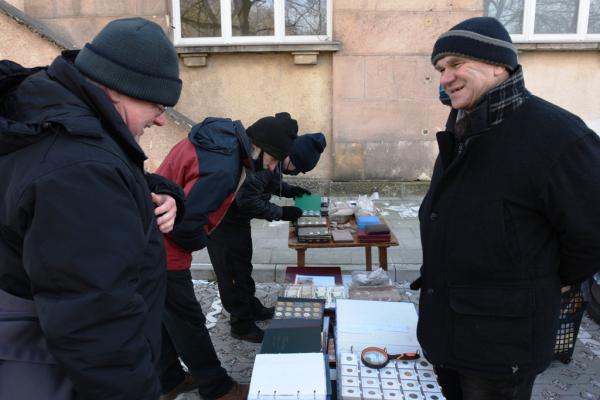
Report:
246,112,298,161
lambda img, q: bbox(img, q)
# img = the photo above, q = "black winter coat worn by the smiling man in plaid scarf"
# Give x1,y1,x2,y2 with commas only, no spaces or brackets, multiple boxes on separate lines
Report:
418,92,600,375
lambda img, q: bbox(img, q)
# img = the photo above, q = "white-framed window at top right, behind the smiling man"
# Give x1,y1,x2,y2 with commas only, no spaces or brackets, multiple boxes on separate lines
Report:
484,0,600,42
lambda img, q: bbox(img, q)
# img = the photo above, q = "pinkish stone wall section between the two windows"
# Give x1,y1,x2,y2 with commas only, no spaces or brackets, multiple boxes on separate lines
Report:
333,0,482,180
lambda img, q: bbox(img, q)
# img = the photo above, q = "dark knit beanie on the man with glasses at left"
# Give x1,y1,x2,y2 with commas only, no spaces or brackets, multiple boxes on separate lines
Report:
75,18,181,107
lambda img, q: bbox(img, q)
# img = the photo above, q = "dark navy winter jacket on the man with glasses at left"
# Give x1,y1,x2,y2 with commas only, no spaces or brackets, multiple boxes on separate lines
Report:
0,52,166,400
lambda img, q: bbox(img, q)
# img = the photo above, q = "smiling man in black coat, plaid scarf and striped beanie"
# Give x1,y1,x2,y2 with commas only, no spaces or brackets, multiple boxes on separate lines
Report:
412,17,600,400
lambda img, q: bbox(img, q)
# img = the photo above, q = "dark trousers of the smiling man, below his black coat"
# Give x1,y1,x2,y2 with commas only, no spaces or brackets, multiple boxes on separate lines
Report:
435,367,537,400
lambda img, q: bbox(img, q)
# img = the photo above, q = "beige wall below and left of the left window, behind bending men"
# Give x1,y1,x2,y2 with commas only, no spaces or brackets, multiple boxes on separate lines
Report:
11,0,332,178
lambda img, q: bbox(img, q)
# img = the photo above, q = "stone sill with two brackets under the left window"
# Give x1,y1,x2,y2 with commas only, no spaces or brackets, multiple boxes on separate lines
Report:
177,42,342,67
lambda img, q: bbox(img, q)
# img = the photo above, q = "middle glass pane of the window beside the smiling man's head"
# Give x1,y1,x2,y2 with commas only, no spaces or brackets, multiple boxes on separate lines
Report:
534,0,579,33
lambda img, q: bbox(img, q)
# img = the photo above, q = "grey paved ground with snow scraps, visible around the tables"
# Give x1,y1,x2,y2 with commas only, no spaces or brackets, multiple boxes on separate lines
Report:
184,196,600,400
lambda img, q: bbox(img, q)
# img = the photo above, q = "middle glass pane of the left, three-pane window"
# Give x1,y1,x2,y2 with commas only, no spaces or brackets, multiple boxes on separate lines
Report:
231,0,275,36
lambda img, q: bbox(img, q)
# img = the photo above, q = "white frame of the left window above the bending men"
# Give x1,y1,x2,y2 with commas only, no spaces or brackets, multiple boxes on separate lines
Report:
171,0,333,46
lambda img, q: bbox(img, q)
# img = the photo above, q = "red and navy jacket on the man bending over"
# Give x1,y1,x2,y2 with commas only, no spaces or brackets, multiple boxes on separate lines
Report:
156,118,252,271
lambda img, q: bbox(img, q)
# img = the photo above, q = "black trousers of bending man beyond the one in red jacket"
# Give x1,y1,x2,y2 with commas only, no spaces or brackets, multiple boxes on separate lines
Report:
207,221,263,326
